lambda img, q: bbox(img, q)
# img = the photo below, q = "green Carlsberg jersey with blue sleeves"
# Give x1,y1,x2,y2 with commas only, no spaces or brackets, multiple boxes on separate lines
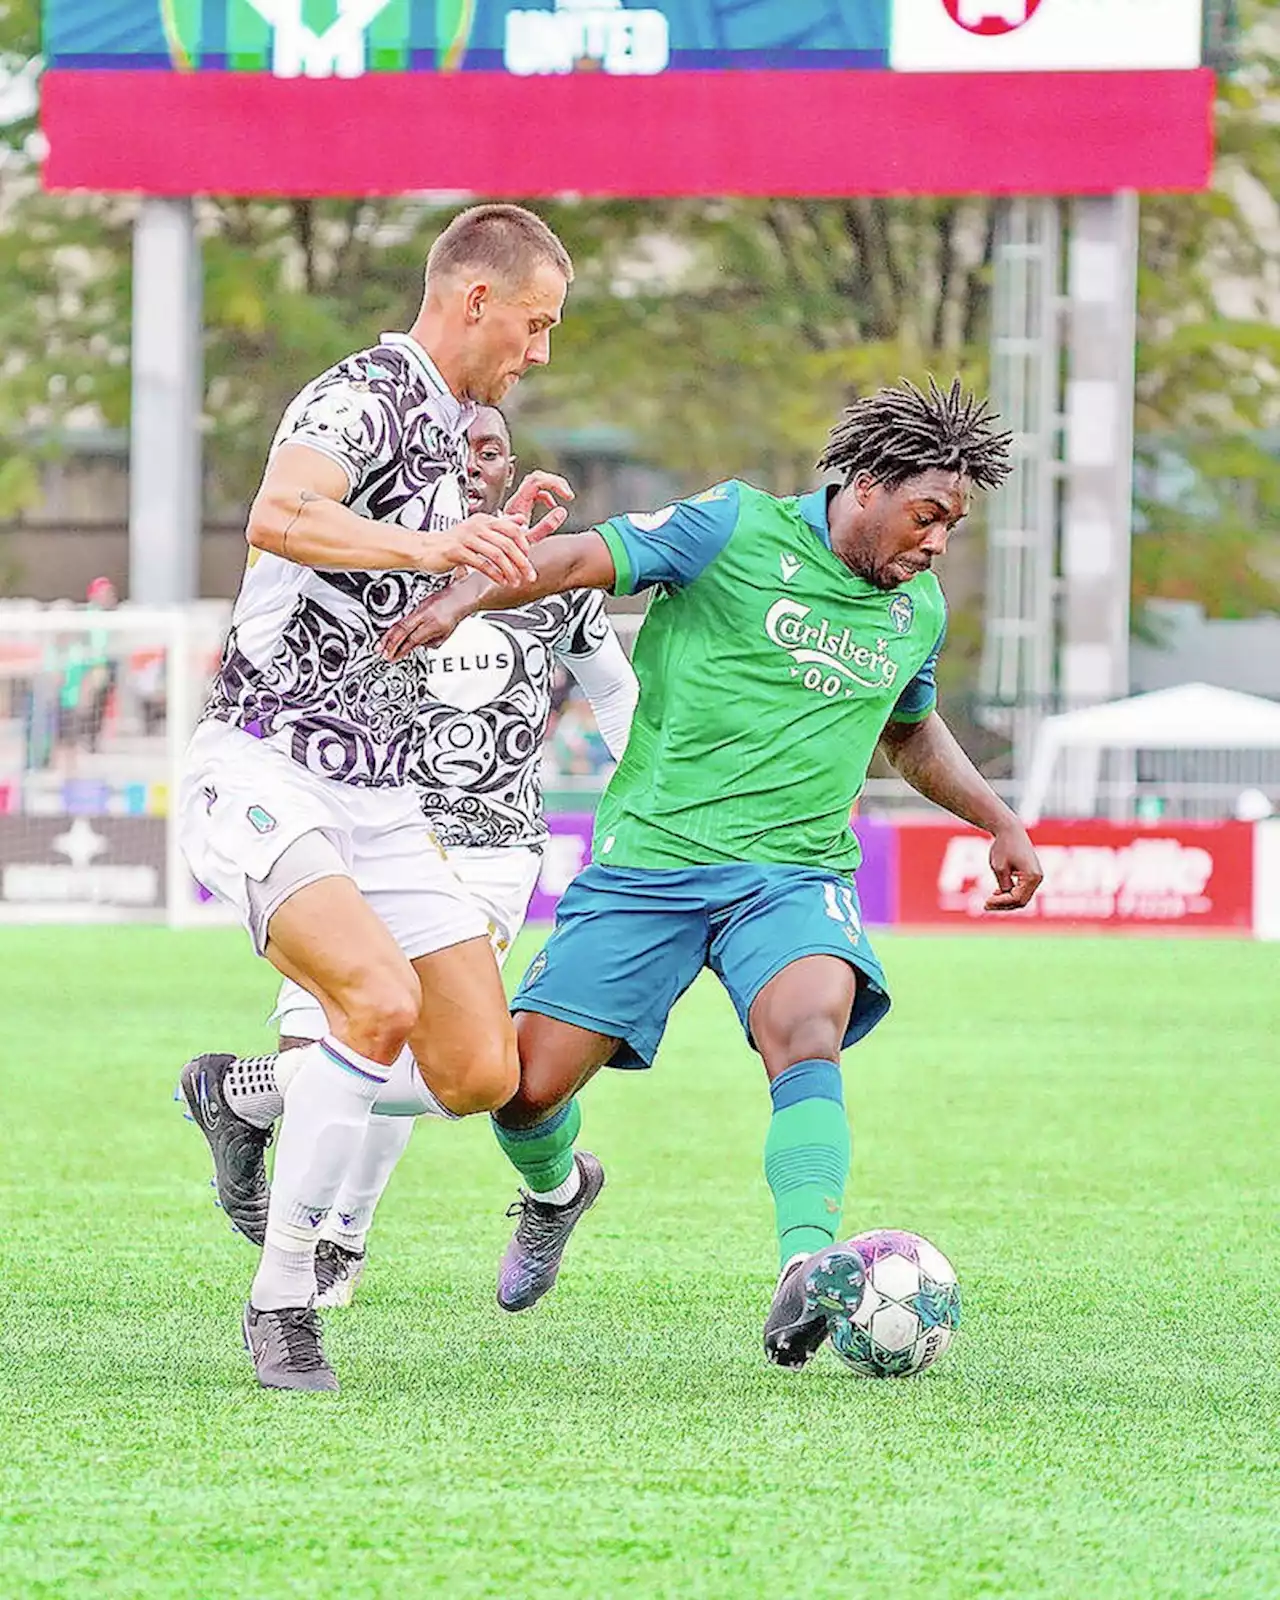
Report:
594,482,946,870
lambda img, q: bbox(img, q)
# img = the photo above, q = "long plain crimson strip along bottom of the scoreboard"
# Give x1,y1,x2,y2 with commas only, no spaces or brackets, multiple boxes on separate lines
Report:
40,67,1214,197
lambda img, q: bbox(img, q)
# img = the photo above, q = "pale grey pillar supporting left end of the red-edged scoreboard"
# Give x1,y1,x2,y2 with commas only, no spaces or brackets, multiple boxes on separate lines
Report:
130,198,202,605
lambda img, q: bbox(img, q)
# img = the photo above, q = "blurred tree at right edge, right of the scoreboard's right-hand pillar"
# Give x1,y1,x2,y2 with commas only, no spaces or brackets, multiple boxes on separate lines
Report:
1133,0,1280,627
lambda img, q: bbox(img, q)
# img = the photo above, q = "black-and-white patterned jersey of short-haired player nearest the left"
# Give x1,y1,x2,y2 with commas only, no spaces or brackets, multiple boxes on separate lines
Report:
205,333,475,787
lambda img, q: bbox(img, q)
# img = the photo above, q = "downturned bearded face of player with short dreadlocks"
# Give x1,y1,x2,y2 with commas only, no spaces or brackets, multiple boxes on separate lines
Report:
832,469,971,589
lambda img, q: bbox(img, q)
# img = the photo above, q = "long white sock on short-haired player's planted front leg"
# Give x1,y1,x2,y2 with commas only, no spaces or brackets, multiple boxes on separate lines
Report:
250,1035,390,1310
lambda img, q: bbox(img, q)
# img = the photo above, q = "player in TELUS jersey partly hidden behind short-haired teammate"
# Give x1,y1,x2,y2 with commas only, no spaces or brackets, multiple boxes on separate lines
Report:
264,406,638,1306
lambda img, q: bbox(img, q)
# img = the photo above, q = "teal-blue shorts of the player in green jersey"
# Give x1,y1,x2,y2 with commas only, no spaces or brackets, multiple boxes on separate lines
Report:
512,862,890,1067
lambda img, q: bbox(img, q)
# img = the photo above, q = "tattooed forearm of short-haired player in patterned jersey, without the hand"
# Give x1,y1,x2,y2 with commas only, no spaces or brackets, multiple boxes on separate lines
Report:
245,485,430,573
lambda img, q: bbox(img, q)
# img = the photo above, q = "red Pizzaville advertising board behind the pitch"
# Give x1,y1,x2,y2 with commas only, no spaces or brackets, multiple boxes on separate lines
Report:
898,822,1254,933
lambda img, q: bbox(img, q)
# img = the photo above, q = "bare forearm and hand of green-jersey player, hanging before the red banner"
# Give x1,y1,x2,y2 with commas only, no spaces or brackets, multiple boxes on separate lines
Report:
880,710,1045,910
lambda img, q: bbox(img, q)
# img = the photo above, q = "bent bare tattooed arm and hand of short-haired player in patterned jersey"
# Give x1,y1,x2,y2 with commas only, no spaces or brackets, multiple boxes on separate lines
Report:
245,445,536,584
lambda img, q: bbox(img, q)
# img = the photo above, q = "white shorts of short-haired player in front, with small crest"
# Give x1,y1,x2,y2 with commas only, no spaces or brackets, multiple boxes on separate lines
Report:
178,722,488,960
